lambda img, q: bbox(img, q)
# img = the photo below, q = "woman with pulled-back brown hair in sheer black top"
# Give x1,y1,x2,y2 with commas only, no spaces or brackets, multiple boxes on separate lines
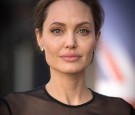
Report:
0,0,135,115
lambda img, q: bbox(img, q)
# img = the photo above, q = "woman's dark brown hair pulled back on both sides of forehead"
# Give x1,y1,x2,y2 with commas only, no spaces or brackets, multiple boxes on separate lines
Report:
34,0,104,34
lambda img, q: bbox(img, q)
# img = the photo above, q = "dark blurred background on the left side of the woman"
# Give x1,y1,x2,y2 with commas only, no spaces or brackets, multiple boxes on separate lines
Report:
0,0,49,95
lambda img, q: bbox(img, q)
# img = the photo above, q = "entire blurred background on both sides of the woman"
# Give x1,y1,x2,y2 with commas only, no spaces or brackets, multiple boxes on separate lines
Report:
0,0,135,107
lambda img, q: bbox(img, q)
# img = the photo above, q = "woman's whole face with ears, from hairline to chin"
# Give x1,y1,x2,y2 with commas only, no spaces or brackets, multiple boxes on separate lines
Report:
36,0,99,73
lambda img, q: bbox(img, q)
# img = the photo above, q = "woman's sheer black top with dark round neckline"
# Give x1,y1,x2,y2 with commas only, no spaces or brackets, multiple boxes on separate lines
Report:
0,87,135,115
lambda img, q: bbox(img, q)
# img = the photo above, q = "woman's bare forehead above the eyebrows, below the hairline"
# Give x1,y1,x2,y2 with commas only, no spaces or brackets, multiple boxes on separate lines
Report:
46,0,93,22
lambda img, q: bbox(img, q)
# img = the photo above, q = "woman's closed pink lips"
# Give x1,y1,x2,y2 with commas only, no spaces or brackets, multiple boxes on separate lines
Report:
60,54,81,62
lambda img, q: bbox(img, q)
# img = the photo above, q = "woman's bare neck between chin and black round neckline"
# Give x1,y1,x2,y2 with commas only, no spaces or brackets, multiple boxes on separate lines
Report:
46,70,92,105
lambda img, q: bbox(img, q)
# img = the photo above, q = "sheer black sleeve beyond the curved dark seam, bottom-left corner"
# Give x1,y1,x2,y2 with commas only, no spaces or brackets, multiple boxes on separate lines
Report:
0,98,12,115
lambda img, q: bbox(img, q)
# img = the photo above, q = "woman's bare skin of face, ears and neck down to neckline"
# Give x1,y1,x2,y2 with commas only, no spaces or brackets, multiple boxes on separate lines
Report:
35,0,100,105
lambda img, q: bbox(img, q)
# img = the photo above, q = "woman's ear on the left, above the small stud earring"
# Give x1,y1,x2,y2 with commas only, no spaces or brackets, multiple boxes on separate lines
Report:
35,28,43,49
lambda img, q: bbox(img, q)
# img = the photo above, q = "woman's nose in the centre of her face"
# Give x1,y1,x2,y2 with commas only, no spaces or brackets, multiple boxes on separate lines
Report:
65,33,77,49
